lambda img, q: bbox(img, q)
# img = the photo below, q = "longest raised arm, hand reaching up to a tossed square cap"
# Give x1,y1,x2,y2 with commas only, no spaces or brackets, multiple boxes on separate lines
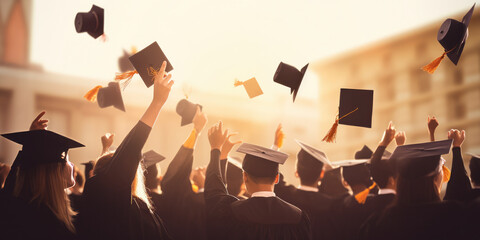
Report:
105,61,173,186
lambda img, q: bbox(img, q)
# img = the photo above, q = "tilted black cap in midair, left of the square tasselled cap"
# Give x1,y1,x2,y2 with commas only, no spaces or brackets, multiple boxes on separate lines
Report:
273,62,308,102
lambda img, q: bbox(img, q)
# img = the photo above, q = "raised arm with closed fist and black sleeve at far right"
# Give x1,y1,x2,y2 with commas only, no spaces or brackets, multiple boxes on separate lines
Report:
443,129,472,201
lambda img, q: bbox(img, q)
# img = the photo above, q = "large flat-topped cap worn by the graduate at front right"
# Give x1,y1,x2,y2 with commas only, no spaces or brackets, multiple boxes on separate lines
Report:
390,139,452,177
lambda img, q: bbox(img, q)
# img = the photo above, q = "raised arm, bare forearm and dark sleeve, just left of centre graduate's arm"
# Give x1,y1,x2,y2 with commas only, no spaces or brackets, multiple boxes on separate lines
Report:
161,107,208,195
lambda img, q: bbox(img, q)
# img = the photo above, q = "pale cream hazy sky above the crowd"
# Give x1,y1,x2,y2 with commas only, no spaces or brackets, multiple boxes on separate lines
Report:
30,0,478,99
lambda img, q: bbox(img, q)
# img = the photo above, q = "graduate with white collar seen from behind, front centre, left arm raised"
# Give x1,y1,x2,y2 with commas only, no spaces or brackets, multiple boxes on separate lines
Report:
205,122,311,239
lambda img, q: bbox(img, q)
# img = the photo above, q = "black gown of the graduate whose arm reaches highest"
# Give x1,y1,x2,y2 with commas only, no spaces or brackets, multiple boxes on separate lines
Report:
78,121,169,239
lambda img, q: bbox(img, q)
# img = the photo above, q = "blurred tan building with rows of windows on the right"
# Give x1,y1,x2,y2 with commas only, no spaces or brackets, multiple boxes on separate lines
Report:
312,9,480,165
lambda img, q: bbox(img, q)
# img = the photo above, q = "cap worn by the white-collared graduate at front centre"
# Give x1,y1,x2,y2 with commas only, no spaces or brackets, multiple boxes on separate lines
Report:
237,143,288,177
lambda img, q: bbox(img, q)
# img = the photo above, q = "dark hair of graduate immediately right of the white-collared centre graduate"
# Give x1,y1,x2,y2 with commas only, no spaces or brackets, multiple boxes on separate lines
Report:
297,149,323,185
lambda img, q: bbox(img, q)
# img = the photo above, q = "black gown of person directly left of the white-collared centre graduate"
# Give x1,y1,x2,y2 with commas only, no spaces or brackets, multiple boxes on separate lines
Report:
157,146,207,239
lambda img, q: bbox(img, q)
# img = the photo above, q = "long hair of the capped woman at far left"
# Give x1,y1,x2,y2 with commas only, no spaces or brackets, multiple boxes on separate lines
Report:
13,163,76,233
